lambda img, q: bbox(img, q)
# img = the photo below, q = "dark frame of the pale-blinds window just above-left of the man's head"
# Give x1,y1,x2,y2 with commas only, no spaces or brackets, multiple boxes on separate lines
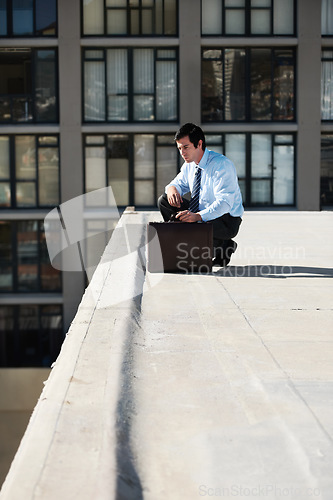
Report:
81,46,179,125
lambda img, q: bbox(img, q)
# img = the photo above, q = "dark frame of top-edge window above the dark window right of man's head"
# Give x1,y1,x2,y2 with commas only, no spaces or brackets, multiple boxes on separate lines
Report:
200,0,297,38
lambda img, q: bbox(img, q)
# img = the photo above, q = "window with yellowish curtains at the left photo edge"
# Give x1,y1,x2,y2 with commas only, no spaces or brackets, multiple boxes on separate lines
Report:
0,135,60,208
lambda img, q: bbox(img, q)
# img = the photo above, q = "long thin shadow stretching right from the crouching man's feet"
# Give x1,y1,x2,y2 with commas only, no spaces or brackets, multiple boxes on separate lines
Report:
213,264,333,279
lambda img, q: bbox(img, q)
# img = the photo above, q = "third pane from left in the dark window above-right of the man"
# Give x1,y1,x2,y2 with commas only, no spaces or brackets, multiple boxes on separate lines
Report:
251,49,272,120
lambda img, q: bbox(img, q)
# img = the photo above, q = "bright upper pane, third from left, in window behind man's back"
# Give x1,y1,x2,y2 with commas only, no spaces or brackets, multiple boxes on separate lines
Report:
251,134,272,176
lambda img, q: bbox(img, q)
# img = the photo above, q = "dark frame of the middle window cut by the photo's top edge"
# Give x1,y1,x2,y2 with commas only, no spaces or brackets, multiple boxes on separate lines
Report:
80,0,180,38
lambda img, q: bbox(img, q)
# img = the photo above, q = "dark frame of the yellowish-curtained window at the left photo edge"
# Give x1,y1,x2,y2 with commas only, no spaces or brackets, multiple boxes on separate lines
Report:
0,134,61,208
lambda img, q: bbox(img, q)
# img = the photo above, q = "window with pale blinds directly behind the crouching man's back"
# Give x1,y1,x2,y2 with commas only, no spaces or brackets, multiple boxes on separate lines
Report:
206,133,295,206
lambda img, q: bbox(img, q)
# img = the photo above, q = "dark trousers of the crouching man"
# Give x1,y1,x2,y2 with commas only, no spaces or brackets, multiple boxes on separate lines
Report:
157,193,242,256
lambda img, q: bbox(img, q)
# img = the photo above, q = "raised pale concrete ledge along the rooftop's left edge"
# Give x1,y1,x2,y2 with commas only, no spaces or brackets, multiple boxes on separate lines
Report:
0,212,147,500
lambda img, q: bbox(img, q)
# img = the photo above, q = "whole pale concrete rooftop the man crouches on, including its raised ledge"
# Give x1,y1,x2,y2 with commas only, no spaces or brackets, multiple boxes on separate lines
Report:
0,211,333,500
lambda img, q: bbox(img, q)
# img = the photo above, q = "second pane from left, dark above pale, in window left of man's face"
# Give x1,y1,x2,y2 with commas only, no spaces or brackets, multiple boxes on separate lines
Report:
108,135,129,205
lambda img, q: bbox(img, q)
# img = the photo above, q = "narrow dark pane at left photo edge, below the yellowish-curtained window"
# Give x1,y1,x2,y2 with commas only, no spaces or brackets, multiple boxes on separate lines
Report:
0,221,13,291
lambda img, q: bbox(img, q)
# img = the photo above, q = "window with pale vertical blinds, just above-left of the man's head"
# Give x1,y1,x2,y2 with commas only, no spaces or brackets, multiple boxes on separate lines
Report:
84,48,178,122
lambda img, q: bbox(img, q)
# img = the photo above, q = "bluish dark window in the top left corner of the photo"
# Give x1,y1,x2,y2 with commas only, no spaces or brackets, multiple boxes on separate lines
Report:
0,0,57,37
